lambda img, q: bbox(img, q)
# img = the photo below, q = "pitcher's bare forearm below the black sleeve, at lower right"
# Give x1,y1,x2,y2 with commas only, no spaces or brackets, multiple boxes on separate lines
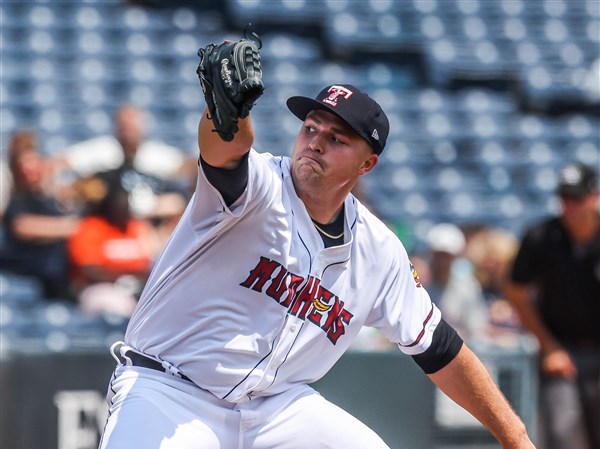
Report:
428,344,535,449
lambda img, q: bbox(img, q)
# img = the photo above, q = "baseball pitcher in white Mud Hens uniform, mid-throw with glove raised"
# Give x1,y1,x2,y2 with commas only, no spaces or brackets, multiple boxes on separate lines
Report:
100,32,534,449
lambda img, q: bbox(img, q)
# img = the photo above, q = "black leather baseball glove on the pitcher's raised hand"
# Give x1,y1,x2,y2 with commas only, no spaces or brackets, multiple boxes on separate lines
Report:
196,33,265,142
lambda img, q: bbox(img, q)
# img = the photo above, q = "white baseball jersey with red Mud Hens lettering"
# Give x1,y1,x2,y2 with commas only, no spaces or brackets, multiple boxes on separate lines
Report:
125,150,441,402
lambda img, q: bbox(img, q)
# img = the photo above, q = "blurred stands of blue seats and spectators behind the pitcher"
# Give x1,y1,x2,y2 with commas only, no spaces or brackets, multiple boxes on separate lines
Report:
0,0,600,449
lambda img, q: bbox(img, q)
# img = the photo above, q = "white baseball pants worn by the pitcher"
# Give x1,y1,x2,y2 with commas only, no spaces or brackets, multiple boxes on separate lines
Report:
100,365,389,449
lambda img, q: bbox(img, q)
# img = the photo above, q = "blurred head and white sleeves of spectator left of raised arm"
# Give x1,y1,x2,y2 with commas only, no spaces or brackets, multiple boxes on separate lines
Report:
55,105,197,191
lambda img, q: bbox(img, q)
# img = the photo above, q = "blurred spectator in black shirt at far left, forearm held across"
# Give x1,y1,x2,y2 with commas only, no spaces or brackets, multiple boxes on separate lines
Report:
1,131,78,299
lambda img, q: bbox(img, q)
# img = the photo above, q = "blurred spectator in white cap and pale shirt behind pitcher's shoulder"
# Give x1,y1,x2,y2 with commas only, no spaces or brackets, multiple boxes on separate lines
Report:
422,223,488,338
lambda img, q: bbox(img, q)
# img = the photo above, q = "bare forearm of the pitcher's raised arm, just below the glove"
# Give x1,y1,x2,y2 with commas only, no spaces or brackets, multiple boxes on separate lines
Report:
198,109,254,170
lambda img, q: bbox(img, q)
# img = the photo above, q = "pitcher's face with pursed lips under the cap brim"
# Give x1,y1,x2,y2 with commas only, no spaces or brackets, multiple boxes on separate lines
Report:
292,109,378,193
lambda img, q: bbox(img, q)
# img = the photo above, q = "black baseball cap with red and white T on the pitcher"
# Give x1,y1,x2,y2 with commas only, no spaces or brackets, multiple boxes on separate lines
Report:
286,84,390,154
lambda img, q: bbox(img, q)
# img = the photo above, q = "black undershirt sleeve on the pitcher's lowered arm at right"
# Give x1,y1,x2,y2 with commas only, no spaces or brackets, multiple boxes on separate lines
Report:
412,319,463,374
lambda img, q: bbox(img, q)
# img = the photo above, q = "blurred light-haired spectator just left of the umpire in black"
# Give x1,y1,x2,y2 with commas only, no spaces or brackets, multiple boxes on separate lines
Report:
465,228,520,331
